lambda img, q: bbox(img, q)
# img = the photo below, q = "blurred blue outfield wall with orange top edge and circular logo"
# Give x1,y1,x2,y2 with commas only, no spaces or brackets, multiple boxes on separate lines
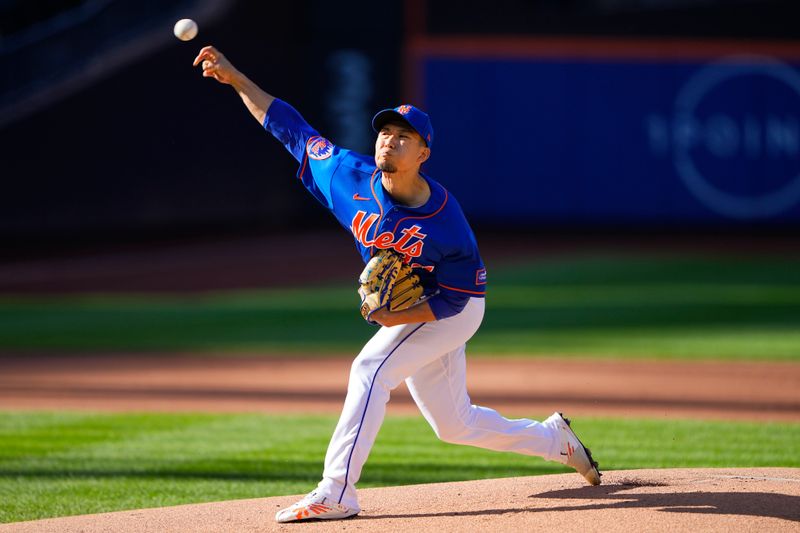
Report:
408,37,800,226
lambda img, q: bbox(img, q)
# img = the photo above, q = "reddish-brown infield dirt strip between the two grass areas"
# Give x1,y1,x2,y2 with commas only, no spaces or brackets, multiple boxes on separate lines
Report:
0,354,800,421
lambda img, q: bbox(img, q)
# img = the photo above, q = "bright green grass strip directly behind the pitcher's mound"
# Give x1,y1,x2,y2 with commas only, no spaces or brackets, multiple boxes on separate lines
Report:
0,413,800,523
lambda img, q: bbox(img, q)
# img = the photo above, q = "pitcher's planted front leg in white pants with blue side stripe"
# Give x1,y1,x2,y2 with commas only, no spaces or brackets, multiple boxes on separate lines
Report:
318,298,483,507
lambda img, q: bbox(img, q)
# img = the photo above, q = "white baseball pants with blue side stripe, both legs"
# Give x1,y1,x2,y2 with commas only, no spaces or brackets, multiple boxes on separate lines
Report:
318,298,560,510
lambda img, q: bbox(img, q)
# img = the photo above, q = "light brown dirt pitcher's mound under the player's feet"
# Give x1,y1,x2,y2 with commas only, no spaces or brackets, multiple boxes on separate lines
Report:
0,468,800,533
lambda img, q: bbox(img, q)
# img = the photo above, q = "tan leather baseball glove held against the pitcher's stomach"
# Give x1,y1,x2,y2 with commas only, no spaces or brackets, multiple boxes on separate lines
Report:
358,250,422,324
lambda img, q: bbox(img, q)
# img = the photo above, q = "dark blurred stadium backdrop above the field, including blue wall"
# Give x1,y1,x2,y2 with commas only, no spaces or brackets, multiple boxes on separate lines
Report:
0,0,800,259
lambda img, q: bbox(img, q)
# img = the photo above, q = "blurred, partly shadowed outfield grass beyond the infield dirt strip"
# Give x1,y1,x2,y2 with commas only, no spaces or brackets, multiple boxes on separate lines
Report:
0,256,800,360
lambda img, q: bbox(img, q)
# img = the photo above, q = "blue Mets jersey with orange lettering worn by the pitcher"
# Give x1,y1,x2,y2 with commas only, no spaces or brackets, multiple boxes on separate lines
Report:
264,99,486,319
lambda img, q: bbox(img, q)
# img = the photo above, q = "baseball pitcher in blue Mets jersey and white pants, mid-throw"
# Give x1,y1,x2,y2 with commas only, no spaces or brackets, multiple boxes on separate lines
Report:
194,46,600,522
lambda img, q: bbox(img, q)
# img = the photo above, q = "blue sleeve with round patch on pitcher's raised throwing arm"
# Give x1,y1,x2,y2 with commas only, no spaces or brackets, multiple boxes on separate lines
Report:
264,98,340,210
